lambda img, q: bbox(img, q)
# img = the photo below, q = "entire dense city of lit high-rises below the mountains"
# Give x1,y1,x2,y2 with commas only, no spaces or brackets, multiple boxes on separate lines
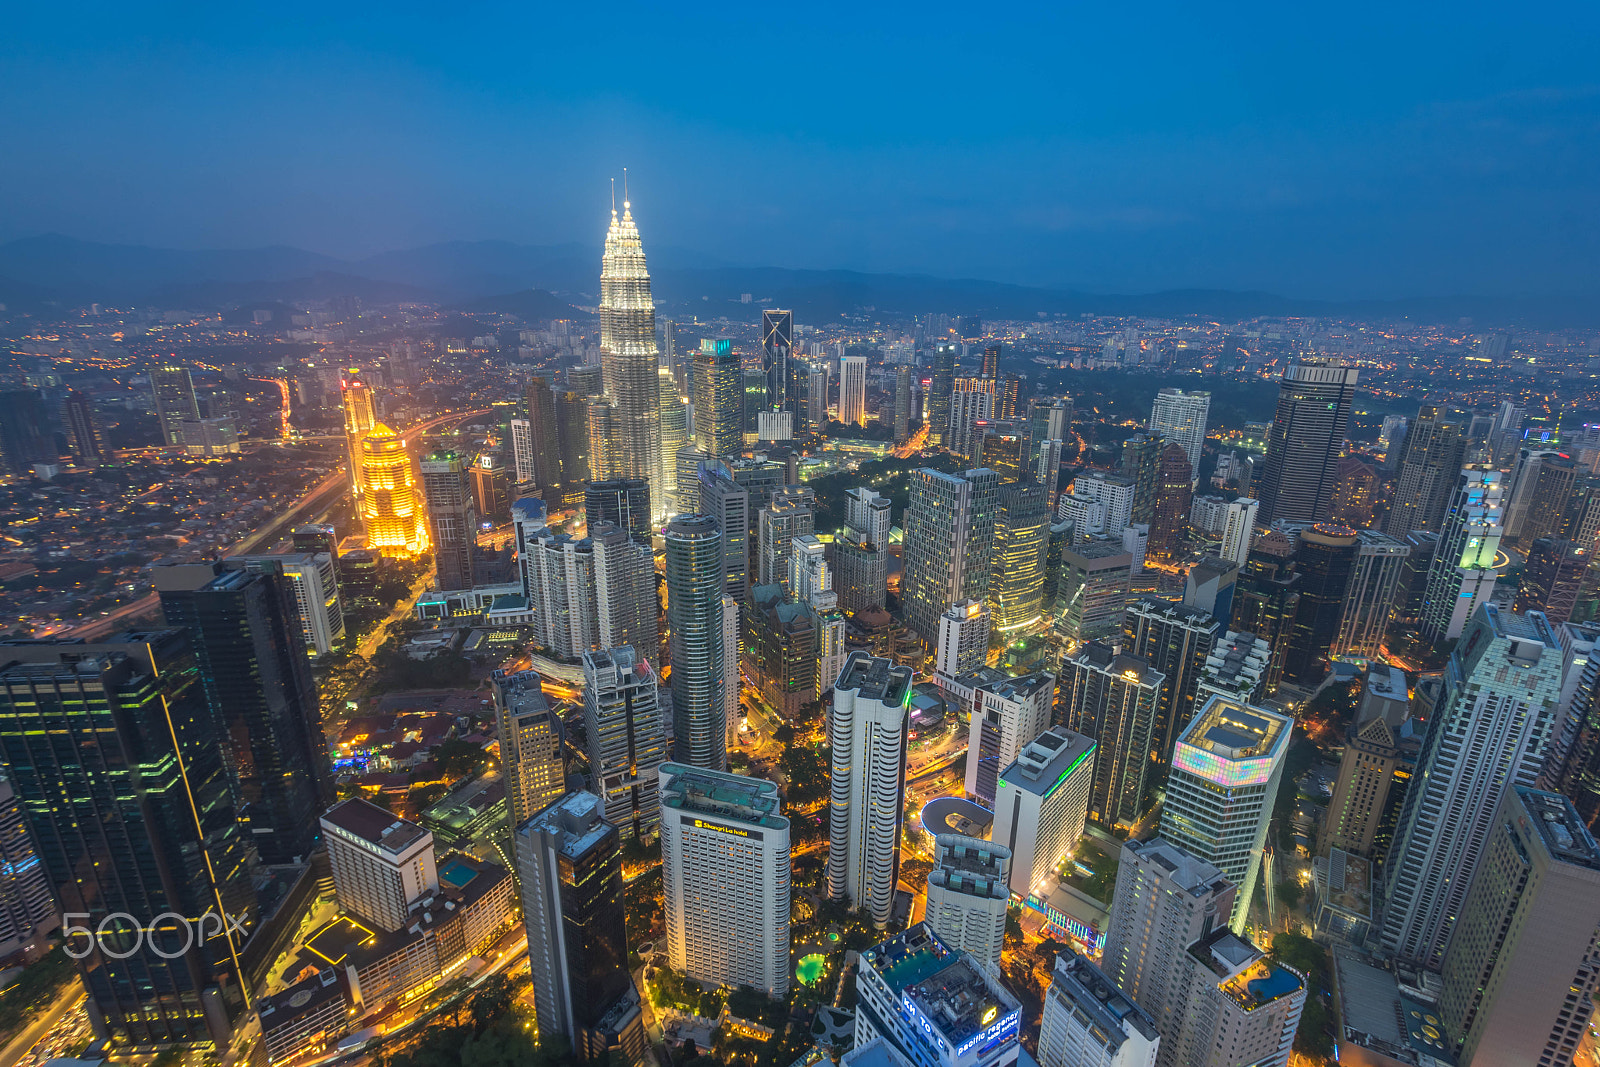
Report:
0,202,1600,1067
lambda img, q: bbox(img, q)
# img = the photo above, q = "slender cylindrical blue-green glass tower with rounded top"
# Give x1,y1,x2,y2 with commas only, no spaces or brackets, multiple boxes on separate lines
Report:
666,514,728,771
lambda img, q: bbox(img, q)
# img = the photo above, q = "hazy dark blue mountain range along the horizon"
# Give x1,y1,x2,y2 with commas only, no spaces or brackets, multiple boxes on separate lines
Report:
0,234,1600,328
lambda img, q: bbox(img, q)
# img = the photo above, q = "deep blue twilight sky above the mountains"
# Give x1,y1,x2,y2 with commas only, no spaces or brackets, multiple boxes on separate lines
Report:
0,0,1600,298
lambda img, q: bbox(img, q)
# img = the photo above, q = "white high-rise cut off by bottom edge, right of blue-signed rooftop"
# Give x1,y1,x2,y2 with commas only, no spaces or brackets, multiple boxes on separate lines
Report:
1035,949,1162,1067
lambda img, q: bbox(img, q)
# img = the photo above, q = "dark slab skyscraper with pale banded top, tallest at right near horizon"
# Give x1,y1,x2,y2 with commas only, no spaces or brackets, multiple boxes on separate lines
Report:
1256,358,1357,528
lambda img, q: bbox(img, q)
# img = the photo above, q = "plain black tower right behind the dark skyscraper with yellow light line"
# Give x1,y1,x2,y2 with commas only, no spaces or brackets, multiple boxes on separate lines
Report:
154,557,333,864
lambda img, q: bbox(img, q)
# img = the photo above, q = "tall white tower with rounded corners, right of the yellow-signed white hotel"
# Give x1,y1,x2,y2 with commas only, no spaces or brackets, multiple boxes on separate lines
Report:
827,653,912,929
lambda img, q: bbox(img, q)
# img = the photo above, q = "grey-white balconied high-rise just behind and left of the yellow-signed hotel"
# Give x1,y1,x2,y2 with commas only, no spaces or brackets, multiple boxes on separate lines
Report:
584,645,667,838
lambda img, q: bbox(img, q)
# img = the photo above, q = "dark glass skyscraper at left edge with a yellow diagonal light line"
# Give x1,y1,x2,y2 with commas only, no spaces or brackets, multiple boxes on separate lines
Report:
0,630,256,1048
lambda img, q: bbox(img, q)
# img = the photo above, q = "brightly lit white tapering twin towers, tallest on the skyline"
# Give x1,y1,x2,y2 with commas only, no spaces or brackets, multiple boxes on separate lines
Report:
600,200,667,518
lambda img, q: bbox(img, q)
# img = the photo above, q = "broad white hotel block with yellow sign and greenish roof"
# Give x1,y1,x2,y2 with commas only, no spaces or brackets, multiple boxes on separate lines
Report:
661,763,789,1000
